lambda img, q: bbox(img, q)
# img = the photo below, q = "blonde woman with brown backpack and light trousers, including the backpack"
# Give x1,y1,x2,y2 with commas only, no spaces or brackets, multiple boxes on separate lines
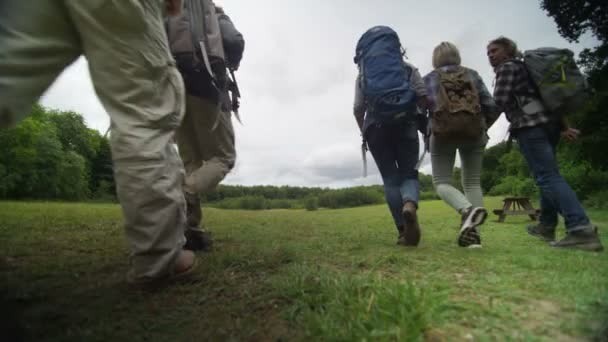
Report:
424,42,500,248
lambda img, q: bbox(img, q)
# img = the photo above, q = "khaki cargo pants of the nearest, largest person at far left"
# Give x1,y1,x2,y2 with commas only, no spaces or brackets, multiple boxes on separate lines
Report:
0,0,185,281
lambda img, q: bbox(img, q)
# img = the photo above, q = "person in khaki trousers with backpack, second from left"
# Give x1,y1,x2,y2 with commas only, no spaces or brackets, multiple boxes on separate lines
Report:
167,0,245,250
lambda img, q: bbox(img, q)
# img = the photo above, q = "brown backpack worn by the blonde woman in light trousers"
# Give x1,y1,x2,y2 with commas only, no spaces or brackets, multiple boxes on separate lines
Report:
431,67,485,142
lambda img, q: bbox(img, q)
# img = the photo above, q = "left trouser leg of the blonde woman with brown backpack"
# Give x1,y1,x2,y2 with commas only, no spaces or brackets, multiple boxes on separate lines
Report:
430,136,473,214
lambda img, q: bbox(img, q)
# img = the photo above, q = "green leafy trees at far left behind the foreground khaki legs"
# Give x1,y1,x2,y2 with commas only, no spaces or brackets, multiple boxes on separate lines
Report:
0,105,114,200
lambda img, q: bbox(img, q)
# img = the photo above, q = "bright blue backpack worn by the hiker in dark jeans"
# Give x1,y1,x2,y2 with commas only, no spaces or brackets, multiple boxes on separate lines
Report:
354,26,416,123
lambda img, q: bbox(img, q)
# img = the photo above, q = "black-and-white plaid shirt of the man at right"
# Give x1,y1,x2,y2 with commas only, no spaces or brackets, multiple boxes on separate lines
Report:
494,60,551,130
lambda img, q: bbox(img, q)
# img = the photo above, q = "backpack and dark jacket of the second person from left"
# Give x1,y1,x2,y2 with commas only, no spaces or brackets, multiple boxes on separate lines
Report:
166,0,244,118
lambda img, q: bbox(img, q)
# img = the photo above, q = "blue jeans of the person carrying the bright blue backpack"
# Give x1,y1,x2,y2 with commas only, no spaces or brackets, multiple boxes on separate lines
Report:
365,122,420,227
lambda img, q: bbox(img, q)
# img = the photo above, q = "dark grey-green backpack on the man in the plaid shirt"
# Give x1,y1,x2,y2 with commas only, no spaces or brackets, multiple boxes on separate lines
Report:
524,48,589,115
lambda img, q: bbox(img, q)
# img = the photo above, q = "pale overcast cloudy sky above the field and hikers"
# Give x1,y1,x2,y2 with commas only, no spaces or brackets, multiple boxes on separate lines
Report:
42,0,595,187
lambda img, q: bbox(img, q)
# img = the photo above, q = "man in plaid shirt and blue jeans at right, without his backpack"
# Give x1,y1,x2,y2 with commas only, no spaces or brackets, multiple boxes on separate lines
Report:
487,37,603,251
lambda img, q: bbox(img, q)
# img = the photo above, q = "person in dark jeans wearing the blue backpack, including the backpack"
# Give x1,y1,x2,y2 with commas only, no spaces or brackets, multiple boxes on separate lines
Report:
354,26,426,246
